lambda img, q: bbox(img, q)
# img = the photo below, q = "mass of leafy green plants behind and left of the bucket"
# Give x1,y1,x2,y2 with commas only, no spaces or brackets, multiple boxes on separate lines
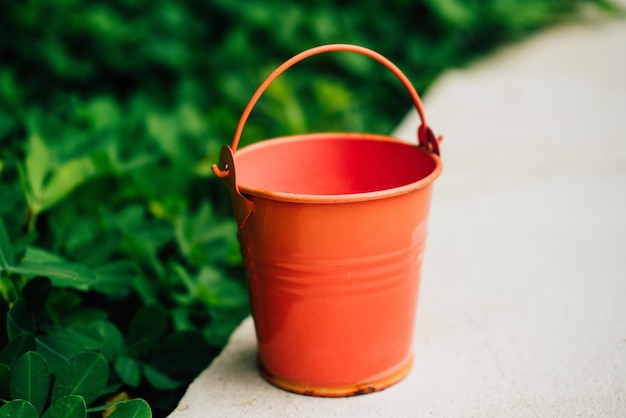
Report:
0,0,613,416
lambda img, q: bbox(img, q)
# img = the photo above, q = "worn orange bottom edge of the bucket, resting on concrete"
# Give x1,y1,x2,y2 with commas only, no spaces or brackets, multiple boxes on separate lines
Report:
258,355,413,398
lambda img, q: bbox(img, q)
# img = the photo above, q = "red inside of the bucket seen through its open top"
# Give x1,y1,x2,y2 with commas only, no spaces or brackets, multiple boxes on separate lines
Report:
235,134,438,195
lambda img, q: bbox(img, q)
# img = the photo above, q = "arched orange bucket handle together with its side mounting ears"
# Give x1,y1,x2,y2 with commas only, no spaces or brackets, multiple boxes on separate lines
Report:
211,44,441,227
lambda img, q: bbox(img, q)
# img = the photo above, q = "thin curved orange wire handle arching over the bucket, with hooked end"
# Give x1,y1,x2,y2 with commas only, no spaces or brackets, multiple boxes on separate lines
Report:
213,44,439,177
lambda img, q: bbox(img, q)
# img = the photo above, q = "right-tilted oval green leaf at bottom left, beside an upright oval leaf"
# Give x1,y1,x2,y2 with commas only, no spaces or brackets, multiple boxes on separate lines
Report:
52,352,109,405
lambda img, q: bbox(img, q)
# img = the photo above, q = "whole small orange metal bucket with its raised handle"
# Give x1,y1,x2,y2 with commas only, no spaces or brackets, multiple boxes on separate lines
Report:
213,44,441,397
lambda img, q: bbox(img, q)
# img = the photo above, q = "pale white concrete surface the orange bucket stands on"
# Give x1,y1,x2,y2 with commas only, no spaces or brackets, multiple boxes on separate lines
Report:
171,13,626,418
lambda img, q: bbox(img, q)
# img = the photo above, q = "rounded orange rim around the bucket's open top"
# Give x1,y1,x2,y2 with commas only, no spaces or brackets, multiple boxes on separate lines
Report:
235,132,443,204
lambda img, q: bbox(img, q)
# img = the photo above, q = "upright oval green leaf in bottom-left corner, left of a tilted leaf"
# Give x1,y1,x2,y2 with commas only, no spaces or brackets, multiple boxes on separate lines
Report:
11,351,50,414
